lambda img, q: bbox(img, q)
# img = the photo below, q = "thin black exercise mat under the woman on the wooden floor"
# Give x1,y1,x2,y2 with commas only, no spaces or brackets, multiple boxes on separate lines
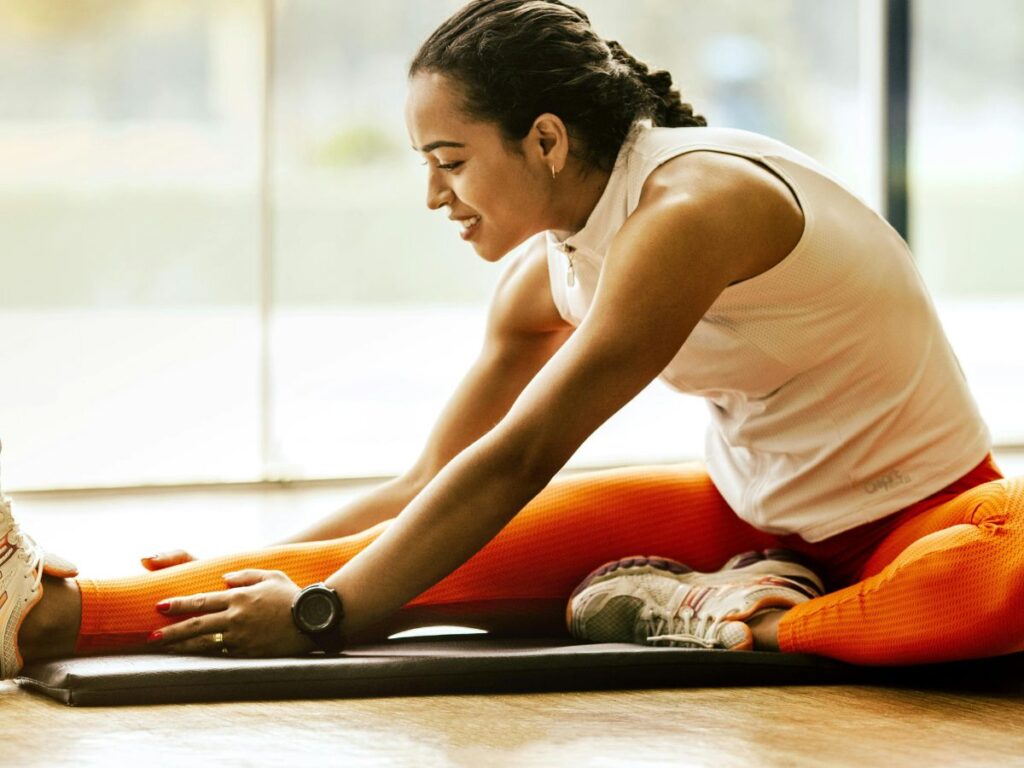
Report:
17,637,1024,706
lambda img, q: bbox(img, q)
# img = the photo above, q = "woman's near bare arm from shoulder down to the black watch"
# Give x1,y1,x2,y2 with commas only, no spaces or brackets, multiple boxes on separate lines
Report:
328,153,802,634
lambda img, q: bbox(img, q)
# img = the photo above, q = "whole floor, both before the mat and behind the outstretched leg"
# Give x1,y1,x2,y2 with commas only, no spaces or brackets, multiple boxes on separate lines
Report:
6,458,1024,768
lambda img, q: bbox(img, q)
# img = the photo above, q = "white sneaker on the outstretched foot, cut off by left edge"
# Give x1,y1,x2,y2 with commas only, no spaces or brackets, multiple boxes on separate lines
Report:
0,442,44,680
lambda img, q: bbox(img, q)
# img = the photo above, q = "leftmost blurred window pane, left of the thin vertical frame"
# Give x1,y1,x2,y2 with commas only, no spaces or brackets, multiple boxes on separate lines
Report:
0,0,261,487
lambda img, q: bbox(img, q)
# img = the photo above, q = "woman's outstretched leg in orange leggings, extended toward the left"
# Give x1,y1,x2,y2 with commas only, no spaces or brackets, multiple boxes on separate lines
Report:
36,464,779,657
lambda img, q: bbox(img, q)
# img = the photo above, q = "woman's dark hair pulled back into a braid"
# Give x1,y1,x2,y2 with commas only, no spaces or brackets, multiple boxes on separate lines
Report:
409,0,708,170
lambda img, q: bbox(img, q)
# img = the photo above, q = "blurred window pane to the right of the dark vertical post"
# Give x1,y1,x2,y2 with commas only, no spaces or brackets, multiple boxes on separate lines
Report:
909,0,1024,445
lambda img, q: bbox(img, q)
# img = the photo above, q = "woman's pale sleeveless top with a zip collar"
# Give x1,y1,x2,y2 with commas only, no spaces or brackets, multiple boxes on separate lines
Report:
520,123,990,542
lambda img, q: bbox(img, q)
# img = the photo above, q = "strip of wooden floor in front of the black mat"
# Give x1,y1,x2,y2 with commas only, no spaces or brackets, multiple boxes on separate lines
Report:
0,683,1024,768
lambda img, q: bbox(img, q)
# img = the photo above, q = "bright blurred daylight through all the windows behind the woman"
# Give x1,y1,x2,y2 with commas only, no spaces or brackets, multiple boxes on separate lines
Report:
0,0,1024,489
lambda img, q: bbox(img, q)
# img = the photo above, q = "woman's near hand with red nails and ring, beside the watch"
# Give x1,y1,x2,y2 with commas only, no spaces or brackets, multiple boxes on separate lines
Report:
150,568,315,657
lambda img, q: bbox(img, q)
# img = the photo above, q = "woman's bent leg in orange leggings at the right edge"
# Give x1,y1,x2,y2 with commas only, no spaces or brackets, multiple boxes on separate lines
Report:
778,478,1024,665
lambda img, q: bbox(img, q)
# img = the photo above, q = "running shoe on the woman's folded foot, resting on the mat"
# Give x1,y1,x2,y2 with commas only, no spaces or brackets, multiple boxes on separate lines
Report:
565,549,824,650
